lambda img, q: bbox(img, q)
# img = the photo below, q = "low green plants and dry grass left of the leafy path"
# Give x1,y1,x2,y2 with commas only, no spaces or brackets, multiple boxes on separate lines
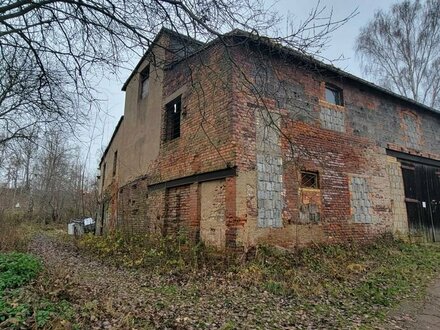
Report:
0,220,80,329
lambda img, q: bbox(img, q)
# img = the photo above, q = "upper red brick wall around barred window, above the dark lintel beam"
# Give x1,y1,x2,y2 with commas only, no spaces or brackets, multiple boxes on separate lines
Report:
148,42,235,183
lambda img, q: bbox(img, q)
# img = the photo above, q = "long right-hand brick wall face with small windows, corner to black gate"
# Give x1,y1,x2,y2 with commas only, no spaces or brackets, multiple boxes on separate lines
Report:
233,48,440,247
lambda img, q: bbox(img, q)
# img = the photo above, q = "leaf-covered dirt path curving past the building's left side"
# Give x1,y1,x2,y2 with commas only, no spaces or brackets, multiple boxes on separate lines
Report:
31,234,300,329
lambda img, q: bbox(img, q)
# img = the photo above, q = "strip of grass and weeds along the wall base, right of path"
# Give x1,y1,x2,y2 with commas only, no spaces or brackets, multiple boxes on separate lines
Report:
79,234,440,328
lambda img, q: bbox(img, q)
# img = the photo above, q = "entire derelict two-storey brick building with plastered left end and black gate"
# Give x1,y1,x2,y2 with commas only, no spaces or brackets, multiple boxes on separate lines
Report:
98,29,440,249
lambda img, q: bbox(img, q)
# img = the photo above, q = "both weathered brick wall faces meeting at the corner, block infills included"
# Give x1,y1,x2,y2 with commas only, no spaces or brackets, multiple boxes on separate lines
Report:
99,34,440,248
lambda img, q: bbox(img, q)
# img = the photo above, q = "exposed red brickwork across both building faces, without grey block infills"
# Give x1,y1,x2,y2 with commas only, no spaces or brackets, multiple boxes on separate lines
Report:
101,36,440,248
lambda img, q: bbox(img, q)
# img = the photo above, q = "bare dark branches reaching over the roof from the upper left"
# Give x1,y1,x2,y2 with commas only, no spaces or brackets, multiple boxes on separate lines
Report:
0,0,358,144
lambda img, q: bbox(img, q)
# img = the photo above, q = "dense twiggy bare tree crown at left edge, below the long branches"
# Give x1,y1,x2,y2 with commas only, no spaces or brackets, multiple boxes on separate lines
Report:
0,45,81,144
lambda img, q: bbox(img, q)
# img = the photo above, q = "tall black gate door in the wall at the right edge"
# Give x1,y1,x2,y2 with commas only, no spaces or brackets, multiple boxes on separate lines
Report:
402,161,440,242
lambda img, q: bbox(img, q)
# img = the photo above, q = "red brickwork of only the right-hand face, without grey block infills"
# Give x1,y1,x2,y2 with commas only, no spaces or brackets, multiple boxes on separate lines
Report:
229,47,424,246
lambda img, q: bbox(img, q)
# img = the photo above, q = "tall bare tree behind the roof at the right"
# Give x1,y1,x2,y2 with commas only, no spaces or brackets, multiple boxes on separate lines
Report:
356,0,440,107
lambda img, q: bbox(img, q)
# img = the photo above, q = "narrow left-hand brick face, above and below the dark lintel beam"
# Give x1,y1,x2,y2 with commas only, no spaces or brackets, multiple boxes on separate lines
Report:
108,40,239,237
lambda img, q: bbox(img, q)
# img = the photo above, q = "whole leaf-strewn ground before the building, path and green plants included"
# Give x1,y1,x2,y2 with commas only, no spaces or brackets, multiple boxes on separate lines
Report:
0,222,440,329
